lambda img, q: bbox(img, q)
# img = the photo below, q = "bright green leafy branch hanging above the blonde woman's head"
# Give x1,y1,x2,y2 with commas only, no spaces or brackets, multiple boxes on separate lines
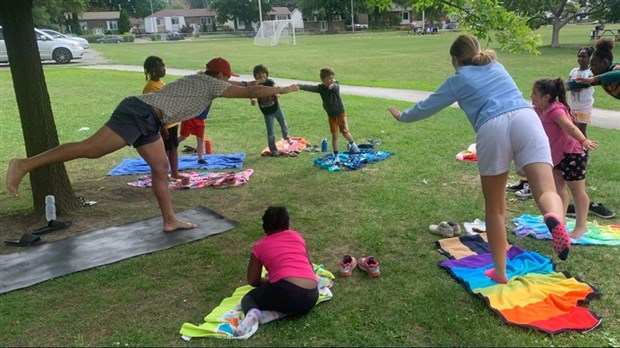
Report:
414,0,552,54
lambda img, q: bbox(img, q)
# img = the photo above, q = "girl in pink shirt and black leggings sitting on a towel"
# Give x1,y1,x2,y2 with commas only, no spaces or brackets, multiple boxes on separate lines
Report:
235,207,319,336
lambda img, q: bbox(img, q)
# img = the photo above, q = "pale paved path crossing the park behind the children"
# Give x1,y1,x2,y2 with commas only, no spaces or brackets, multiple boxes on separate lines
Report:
81,65,620,129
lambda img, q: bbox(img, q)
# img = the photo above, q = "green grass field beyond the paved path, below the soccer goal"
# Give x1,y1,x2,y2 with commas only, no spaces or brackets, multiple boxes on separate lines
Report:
88,25,618,110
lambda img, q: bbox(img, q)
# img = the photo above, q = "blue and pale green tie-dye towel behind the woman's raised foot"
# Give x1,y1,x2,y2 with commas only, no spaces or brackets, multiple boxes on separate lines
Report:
512,214,620,246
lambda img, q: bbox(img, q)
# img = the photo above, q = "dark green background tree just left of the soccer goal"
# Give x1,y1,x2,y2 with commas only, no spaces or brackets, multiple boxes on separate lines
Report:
211,0,272,28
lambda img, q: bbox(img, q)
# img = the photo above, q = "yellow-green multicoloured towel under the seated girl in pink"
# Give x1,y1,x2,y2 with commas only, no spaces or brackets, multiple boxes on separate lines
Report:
179,264,335,341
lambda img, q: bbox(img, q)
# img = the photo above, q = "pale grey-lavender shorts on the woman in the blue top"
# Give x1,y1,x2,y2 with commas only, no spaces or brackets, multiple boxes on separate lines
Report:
476,109,552,176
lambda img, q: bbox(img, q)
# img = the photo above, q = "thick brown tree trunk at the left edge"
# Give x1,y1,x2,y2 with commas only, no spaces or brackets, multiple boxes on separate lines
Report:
0,0,80,213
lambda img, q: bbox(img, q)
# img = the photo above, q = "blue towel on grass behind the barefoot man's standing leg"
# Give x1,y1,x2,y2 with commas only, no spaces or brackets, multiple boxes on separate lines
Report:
108,153,245,176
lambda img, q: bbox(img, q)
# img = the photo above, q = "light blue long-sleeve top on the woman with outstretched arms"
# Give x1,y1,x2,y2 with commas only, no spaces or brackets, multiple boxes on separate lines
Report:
400,62,532,132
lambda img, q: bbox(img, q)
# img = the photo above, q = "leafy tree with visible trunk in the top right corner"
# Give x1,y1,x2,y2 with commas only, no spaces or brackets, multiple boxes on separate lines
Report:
504,0,620,47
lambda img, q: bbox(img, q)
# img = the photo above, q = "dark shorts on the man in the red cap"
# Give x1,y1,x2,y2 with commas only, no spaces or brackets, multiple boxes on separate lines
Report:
105,97,161,147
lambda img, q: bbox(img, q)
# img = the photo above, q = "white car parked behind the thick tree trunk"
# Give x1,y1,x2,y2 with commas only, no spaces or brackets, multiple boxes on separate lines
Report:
0,27,84,64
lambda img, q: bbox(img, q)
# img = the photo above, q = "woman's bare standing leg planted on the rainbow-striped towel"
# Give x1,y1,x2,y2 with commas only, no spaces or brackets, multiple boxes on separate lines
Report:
480,172,508,279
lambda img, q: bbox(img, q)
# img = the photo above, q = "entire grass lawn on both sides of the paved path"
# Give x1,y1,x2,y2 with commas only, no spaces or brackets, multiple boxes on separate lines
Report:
0,27,620,347
